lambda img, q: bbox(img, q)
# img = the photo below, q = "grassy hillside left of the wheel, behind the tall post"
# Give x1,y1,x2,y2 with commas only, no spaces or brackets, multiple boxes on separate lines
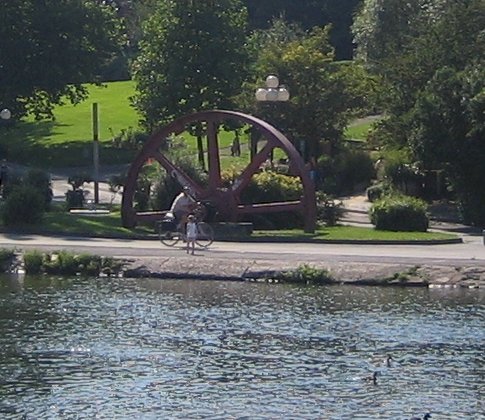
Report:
0,81,138,168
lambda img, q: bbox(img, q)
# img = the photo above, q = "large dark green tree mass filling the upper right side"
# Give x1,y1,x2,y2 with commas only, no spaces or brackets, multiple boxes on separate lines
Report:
356,0,485,225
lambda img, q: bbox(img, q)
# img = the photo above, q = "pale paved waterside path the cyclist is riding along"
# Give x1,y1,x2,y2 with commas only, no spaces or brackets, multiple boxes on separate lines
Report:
0,234,485,265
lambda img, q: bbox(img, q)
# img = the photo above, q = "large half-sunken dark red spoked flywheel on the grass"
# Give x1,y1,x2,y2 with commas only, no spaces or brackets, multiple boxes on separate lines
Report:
121,110,317,232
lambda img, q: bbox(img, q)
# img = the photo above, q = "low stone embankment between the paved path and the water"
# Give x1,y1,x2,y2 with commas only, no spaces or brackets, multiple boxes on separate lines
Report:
124,256,485,289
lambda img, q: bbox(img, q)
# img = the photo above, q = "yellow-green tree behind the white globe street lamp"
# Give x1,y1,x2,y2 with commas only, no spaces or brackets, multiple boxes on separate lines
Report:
247,22,369,161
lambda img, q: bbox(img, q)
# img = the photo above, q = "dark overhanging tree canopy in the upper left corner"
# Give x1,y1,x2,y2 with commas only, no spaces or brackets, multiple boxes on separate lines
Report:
0,0,122,118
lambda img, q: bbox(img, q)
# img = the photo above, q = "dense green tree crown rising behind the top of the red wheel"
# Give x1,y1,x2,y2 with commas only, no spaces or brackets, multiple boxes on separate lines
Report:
133,0,247,128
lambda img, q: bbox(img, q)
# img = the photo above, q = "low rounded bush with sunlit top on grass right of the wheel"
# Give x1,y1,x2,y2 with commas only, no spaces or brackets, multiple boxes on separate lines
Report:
370,195,429,232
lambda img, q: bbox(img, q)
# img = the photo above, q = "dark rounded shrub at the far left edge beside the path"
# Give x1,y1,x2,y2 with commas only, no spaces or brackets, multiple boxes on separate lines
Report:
2,185,45,226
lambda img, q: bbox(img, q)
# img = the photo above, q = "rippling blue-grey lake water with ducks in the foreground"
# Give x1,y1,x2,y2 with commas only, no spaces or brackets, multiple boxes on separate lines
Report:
0,278,485,419
